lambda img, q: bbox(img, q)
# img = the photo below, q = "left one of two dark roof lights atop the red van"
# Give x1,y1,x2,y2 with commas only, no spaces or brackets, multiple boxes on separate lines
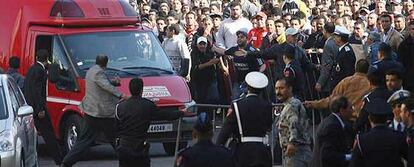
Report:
50,0,85,17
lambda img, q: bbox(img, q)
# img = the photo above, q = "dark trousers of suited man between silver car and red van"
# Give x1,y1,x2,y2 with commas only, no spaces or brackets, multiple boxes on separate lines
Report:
34,113,62,165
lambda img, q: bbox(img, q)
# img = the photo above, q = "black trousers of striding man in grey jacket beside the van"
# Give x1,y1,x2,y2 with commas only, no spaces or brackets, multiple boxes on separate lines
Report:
63,114,116,166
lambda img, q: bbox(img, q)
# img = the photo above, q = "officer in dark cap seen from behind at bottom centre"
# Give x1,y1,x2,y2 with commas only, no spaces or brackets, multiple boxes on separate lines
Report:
177,113,234,167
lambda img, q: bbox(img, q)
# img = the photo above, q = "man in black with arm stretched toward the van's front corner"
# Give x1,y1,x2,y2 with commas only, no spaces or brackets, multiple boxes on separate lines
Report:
115,78,195,167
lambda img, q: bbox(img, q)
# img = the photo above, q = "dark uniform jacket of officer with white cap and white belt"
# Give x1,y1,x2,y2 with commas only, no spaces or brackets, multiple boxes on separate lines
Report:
217,94,272,167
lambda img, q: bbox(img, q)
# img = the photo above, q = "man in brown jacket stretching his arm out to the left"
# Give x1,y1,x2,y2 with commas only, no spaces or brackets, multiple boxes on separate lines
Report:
305,59,371,120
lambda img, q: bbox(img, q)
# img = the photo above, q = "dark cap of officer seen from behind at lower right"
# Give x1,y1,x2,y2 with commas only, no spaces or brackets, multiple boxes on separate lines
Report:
365,98,392,115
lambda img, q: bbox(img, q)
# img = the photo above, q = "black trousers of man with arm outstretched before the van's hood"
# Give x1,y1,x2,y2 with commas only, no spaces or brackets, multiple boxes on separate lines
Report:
117,145,151,167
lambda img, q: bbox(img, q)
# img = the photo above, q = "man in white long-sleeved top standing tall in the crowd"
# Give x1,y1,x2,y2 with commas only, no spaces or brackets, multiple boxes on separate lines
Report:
217,2,253,49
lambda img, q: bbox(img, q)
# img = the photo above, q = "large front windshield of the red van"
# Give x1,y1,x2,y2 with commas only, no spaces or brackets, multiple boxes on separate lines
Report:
62,31,174,77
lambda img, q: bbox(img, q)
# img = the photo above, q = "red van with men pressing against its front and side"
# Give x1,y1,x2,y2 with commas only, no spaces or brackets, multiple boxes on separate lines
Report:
0,0,195,154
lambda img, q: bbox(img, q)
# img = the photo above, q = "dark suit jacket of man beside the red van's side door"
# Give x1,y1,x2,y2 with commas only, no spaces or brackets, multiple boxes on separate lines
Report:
23,62,47,115
